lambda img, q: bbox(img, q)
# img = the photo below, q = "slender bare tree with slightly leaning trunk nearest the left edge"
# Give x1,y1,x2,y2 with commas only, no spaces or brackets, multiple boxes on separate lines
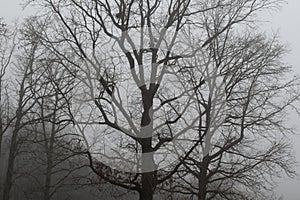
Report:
3,18,46,200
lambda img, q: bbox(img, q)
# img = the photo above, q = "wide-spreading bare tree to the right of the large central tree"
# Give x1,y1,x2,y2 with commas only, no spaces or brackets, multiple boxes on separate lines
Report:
158,32,300,199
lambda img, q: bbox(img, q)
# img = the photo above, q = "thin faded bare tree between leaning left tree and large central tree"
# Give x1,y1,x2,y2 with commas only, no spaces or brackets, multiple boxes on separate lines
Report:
30,47,76,200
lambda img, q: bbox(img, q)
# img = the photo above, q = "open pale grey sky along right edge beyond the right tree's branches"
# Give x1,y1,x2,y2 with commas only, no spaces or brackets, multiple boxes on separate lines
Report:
269,0,300,200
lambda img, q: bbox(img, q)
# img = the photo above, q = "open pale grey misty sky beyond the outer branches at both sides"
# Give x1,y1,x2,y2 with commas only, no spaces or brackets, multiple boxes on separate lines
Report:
0,0,300,200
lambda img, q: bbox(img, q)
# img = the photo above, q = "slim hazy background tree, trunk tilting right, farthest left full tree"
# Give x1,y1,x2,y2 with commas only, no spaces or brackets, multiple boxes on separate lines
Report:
2,24,38,200
